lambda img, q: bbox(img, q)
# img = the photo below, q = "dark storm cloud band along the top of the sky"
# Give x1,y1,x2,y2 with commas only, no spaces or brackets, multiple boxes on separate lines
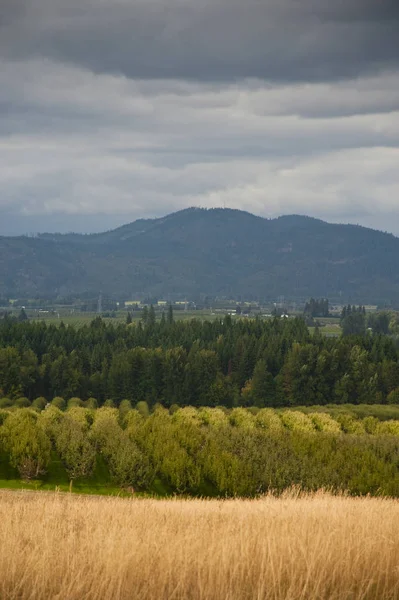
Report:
0,0,399,81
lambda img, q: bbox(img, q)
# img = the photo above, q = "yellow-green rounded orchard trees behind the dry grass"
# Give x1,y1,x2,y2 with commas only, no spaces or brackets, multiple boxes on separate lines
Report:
0,402,399,497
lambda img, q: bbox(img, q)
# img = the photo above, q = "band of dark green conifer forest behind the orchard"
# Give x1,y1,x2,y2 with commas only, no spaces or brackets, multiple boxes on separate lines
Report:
0,313,399,407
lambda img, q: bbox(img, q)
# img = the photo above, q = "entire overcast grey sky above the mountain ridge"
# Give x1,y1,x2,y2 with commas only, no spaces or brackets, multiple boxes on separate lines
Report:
0,0,399,235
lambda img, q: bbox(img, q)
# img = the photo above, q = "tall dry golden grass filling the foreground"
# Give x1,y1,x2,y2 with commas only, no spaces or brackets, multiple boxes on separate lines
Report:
0,492,399,600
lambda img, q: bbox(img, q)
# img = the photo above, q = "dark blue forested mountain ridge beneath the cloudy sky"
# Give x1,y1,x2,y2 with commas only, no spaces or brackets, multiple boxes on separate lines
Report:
0,208,399,306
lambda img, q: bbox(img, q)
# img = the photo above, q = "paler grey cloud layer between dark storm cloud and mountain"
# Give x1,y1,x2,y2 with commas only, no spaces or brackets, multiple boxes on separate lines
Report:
0,59,399,233
